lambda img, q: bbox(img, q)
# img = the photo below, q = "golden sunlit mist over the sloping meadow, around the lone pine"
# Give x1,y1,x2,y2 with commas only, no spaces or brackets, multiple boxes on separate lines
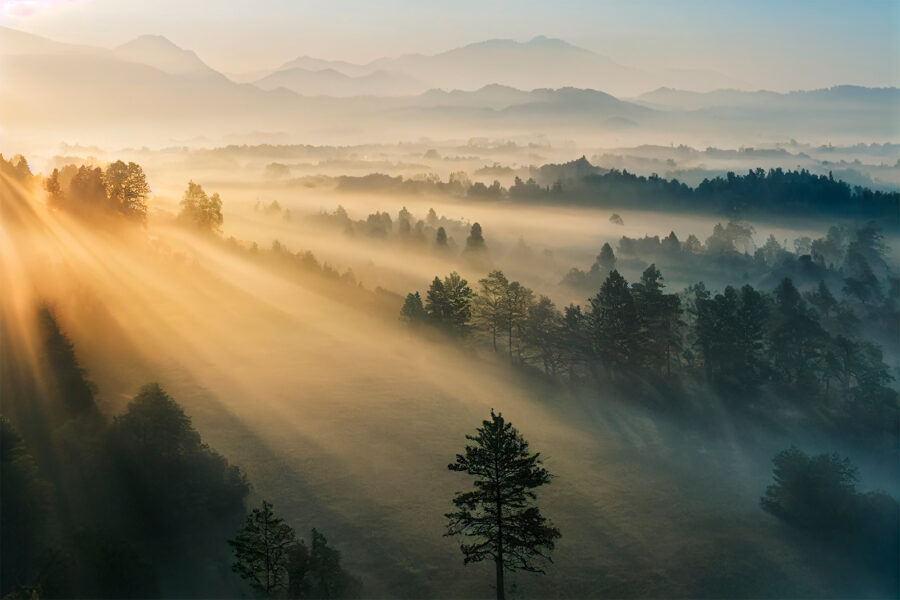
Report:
0,156,896,598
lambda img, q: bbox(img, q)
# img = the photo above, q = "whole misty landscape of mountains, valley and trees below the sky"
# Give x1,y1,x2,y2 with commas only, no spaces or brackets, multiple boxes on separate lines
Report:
0,3,900,598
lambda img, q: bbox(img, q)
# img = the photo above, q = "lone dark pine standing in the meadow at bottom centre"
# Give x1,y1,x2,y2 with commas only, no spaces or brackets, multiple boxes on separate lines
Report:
444,409,560,600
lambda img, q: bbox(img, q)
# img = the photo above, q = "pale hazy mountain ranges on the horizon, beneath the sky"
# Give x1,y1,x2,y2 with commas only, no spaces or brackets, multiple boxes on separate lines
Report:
0,28,900,150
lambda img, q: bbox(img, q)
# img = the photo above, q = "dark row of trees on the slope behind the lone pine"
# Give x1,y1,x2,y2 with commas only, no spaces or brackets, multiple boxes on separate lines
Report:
400,265,900,449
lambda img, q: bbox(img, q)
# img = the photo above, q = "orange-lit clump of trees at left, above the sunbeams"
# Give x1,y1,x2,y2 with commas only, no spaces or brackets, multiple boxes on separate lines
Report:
44,160,150,223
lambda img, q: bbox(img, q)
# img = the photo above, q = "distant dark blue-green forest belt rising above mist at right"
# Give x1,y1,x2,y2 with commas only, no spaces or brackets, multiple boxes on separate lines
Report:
326,157,900,230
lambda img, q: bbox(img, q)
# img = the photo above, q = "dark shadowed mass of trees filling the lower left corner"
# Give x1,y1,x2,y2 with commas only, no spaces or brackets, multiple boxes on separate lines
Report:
0,308,358,598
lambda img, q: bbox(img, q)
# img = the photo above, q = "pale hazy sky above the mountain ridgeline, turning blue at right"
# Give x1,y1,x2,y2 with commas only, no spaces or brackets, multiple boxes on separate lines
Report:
0,0,900,89
